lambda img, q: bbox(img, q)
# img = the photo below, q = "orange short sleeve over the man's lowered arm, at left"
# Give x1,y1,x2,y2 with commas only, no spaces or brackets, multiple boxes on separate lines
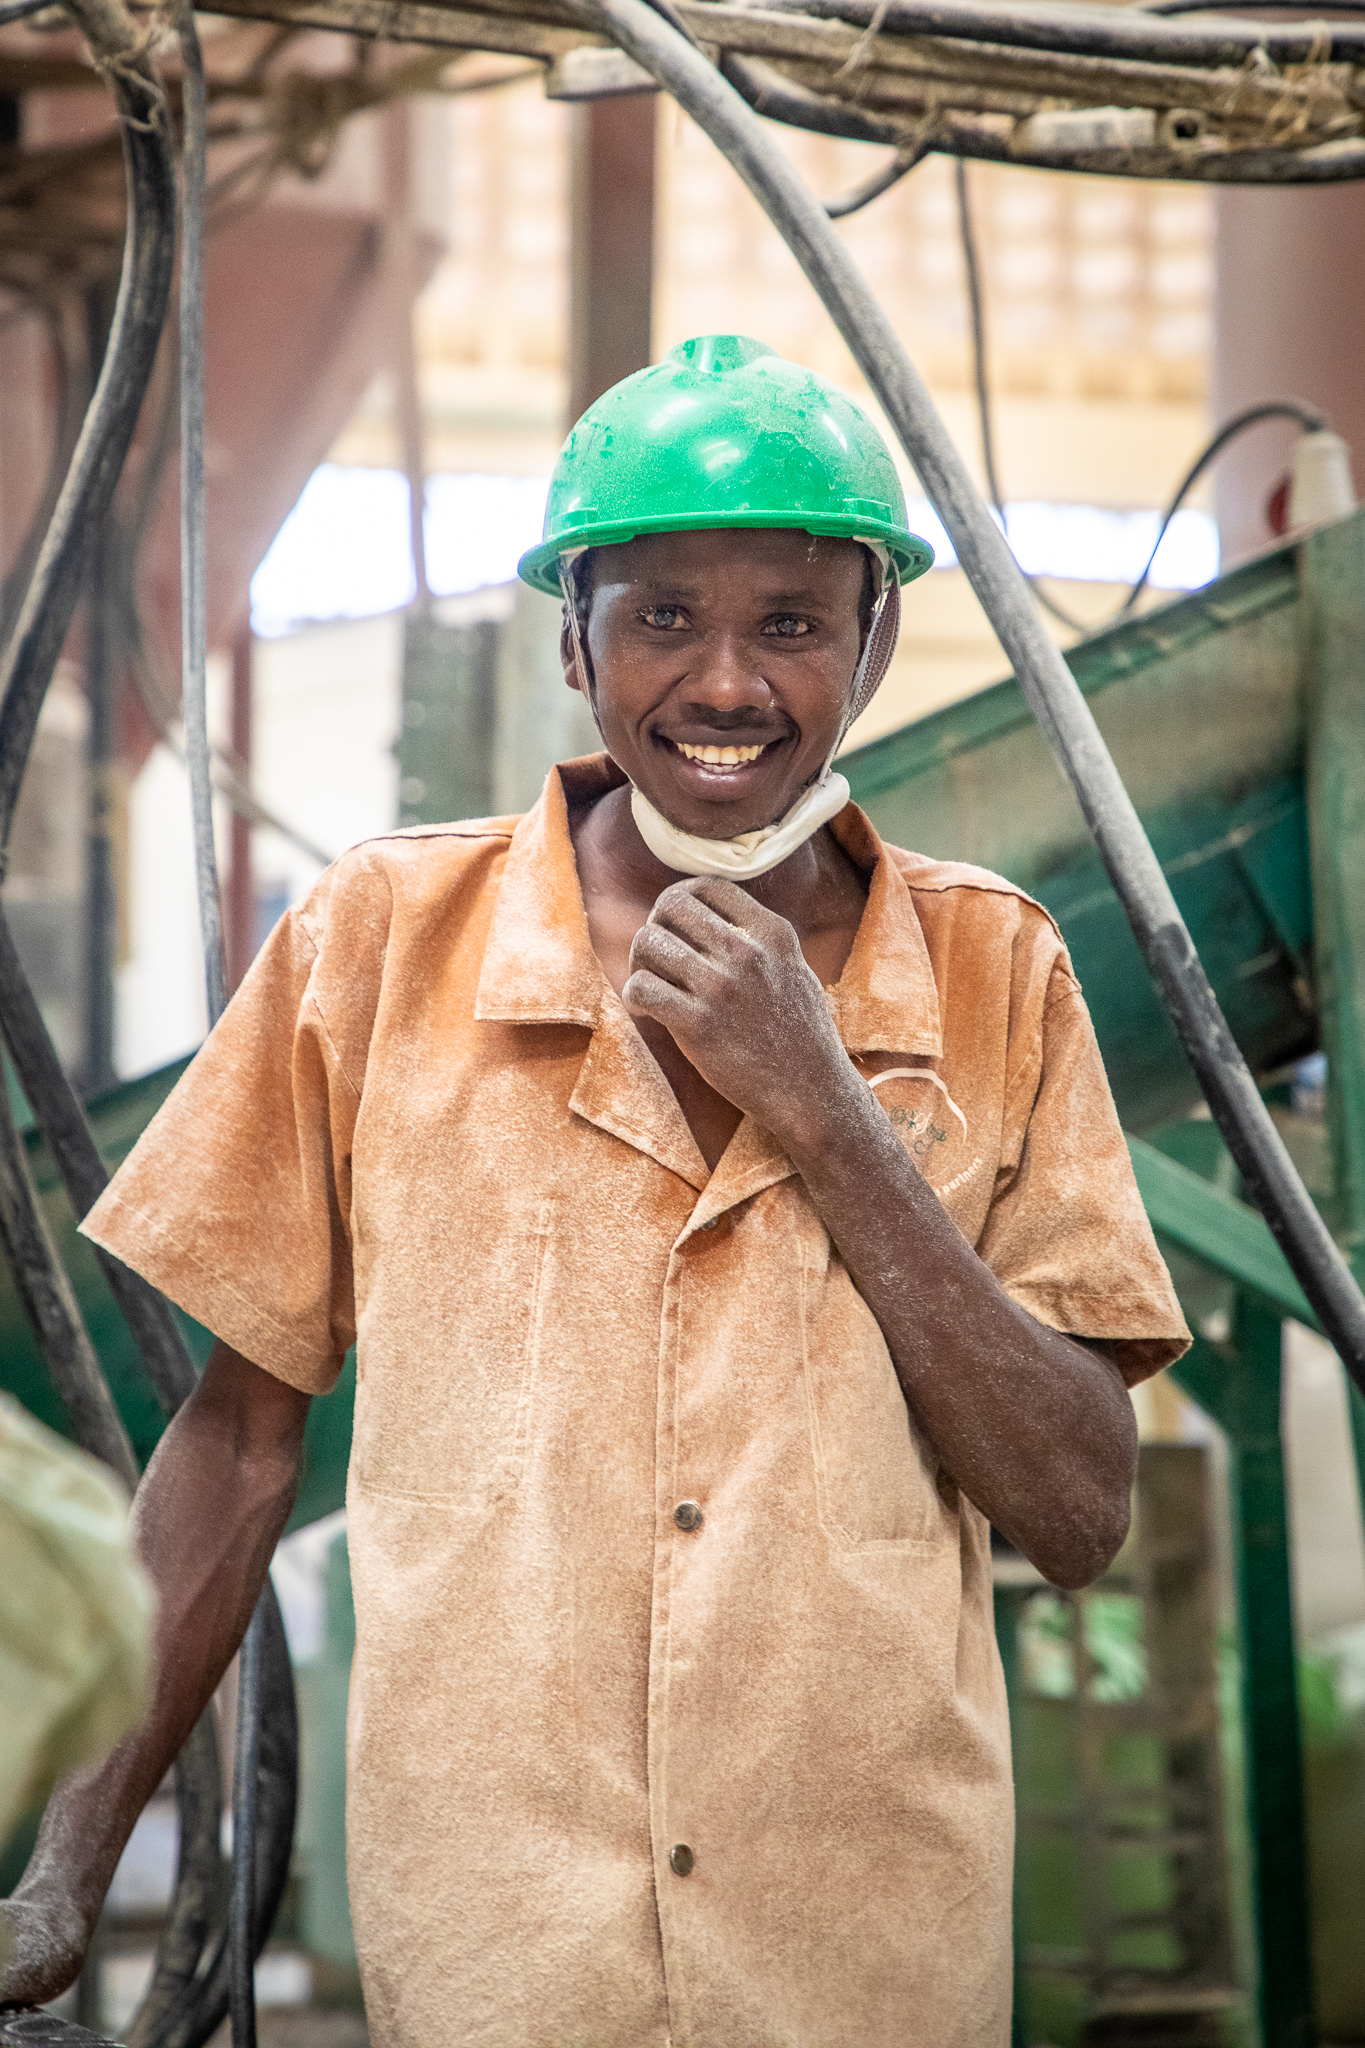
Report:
82,909,360,1395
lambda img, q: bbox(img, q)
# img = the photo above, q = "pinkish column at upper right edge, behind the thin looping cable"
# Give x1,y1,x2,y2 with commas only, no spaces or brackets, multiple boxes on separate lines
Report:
1212,184,1365,565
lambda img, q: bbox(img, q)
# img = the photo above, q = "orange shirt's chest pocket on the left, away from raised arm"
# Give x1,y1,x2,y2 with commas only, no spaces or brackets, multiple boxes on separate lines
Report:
352,1202,553,1513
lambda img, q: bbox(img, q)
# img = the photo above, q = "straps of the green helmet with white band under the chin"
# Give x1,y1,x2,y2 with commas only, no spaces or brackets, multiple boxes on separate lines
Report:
559,541,900,883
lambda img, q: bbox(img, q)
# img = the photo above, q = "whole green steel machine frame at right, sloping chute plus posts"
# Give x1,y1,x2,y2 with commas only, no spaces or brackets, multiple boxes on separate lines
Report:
845,514,1365,2048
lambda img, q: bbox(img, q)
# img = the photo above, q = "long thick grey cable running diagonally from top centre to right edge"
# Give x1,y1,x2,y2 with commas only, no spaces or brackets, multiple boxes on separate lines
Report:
585,0,1365,1391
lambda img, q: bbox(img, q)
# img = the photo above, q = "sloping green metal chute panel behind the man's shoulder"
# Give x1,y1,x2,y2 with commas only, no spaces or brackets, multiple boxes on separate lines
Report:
841,520,1318,1130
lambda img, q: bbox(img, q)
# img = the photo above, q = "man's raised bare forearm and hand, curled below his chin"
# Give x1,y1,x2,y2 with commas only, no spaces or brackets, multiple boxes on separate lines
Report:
624,881,1136,1587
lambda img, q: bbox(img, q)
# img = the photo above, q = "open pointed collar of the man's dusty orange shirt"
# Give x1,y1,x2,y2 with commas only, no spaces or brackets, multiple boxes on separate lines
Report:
475,754,943,1059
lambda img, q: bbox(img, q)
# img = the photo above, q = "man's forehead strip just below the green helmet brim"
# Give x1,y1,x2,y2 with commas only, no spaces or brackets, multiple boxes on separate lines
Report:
591,526,866,604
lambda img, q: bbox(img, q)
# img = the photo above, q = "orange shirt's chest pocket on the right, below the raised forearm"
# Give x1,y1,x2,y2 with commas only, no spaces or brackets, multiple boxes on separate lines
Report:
802,1257,958,1548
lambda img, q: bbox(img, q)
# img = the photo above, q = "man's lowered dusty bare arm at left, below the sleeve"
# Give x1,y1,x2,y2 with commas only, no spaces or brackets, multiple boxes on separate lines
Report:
0,1343,309,2005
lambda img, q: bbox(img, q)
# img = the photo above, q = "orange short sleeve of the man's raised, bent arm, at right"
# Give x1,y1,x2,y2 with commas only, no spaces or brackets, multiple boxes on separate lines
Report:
976,965,1189,1384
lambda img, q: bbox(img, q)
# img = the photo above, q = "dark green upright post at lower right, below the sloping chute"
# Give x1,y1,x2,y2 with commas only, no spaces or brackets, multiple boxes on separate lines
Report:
1175,1292,1314,2048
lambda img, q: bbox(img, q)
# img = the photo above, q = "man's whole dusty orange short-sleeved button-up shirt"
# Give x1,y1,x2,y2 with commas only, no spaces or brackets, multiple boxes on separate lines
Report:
86,758,1185,2048
